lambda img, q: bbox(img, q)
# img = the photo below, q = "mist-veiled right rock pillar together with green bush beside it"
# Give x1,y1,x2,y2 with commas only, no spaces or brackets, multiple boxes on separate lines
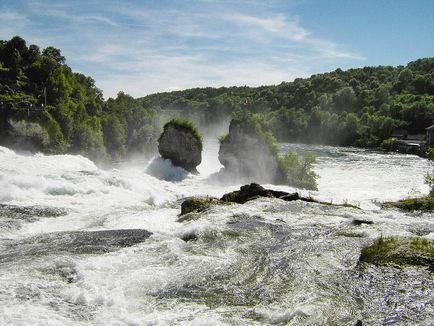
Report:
218,114,317,190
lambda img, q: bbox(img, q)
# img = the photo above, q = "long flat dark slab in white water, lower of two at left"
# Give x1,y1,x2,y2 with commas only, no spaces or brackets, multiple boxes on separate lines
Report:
0,229,152,263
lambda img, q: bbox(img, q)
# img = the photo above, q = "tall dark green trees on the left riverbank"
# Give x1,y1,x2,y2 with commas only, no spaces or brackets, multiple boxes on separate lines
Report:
0,36,158,160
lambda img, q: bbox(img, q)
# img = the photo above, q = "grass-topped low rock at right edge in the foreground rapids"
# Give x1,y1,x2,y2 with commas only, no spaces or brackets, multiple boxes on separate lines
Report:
359,236,434,270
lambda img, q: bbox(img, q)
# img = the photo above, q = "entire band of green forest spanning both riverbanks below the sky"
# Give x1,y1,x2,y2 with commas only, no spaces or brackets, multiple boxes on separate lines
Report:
0,36,434,160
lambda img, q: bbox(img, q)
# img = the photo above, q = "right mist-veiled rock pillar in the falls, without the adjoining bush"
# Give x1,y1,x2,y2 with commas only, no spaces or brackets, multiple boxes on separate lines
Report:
218,119,281,183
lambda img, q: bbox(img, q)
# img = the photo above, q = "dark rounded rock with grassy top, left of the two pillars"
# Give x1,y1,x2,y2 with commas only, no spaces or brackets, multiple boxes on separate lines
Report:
158,119,202,173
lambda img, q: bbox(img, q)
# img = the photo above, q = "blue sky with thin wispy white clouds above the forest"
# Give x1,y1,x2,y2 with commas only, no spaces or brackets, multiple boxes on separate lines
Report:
0,0,434,98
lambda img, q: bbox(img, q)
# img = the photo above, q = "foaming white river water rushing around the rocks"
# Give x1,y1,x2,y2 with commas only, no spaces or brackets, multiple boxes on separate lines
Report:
0,143,434,325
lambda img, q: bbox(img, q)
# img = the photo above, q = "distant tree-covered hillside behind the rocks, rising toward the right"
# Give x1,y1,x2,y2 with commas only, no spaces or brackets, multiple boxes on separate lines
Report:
138,58,434,147
